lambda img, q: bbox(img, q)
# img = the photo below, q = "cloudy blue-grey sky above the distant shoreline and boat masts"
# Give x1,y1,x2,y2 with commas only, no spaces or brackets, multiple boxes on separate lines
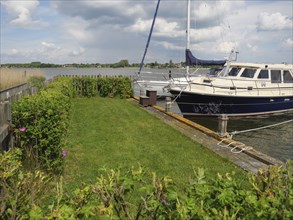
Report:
0,0,293,64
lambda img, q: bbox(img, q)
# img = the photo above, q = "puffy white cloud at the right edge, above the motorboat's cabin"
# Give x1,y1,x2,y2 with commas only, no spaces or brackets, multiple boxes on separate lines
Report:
257,12,293,31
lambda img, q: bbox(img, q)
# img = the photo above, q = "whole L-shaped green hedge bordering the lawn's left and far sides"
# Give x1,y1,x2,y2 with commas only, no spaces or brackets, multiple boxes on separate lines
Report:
12,76,133,173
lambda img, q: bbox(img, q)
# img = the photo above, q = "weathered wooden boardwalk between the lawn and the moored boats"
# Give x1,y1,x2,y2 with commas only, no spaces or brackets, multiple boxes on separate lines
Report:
133,98,283,174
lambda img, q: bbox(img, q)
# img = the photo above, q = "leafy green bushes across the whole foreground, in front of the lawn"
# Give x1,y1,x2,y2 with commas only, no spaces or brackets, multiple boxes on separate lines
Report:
0,150,293,219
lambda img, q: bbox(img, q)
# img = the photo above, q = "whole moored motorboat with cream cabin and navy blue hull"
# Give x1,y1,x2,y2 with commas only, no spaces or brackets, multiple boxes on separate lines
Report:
170,62,293,116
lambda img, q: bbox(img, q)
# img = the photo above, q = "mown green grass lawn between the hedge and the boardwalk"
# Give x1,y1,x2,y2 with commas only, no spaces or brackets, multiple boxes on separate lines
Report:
64,98,246,189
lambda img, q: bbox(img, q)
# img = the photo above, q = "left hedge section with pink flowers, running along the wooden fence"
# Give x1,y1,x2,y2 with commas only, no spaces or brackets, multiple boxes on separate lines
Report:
12,79,73,173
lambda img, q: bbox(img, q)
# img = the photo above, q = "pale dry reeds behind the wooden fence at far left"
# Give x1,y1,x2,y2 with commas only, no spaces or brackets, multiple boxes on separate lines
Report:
0,68,45,90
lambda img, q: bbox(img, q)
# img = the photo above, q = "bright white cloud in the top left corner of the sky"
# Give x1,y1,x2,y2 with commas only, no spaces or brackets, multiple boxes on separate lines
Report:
1,0,46,28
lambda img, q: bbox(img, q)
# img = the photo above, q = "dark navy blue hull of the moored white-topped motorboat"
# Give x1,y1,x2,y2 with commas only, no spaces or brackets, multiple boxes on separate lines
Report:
170,90,293,116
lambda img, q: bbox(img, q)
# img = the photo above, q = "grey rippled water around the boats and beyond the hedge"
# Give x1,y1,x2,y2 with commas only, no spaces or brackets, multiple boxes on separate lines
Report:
42,68,293,162
